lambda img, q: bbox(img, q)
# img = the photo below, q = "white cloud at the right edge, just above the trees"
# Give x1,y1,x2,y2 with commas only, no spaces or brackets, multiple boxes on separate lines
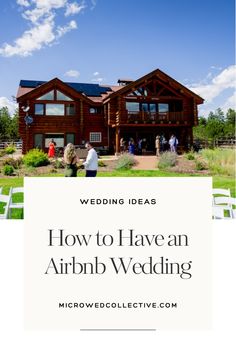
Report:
188,65,236,116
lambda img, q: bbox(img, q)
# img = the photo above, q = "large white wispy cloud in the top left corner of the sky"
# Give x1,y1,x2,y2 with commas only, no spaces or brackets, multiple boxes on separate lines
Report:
0,0,85,57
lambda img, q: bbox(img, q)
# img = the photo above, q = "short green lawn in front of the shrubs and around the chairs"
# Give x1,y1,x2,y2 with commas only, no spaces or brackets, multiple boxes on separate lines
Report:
0,170,236,219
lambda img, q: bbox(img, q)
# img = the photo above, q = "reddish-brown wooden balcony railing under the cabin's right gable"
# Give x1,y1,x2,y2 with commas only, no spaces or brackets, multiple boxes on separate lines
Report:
116,111,189,125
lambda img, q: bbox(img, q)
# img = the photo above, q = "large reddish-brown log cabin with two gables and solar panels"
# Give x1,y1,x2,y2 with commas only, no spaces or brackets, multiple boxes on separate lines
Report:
17,69,204,153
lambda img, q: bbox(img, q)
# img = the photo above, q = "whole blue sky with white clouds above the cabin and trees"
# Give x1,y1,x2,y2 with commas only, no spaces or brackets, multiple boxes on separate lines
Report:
0,0,235,115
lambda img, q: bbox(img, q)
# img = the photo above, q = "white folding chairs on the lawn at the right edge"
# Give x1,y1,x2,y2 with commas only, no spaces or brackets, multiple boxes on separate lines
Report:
212,188,236,219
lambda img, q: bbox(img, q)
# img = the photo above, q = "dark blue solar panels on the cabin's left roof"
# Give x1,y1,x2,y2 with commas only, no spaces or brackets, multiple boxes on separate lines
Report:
20,80,111,97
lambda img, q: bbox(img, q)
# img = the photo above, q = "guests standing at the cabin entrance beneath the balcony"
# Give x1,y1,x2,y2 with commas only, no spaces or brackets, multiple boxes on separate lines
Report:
120,134,179,156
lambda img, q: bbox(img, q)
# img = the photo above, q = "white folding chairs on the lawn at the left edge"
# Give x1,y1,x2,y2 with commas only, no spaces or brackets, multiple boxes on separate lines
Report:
0,187,24,219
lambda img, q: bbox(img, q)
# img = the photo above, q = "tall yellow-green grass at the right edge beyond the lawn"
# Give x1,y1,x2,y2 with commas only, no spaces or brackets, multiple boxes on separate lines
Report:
200,148,235,177
